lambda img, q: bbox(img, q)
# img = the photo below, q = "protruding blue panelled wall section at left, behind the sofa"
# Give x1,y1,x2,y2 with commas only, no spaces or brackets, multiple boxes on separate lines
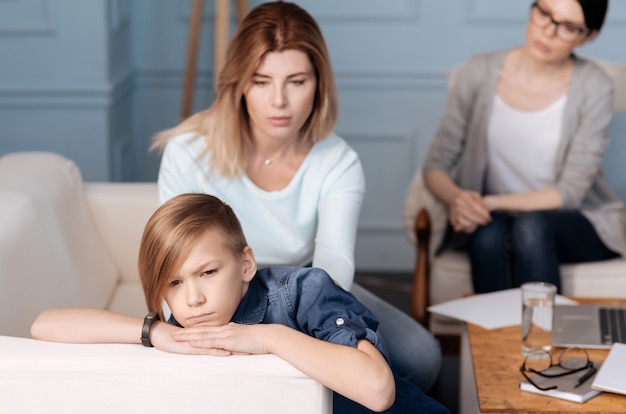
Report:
0,0,134,180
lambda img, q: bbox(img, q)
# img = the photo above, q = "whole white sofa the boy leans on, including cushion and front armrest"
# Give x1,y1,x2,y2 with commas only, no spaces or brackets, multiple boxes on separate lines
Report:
0,152,332,413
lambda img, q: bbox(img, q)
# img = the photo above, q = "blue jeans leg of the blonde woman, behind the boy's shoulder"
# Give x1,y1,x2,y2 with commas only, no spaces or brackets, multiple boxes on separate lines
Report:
350,283,441,392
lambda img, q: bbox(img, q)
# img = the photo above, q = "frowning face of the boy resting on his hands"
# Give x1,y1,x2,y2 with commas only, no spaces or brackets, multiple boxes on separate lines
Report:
165,229,256,328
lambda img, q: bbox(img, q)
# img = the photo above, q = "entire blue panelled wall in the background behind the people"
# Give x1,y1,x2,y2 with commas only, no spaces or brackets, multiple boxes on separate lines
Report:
0,0,626,270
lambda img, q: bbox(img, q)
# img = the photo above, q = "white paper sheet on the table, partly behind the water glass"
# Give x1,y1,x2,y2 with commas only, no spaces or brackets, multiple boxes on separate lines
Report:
428,288,577,329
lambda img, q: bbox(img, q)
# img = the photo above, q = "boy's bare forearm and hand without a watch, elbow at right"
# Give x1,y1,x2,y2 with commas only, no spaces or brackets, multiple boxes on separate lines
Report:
173,323,395,411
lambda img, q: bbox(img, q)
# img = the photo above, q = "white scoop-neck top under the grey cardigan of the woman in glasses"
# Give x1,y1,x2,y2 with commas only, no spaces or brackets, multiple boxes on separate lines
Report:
487,95,566,194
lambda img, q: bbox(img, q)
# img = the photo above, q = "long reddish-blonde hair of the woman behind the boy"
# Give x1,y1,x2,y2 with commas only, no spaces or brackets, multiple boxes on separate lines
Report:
152,1,338,177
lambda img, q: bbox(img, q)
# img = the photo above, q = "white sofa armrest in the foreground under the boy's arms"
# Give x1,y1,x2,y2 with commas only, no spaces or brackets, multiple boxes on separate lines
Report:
0,336,332,414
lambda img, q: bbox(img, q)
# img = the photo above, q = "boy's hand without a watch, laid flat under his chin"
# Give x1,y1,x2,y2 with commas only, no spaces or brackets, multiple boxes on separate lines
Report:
171,322,273,355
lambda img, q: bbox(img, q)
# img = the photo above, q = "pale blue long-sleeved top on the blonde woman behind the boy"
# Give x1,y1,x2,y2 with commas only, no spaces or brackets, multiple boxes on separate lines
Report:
158,133,365,290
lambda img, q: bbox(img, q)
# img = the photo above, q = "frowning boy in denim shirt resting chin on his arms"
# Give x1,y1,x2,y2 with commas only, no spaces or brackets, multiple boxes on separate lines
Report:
31,194,445,412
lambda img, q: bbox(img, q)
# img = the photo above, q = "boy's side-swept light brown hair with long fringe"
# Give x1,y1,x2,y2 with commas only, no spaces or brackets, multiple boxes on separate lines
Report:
138,194,248,320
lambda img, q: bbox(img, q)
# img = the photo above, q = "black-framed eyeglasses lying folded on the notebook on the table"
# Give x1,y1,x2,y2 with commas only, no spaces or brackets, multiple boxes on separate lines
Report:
520,348,594,391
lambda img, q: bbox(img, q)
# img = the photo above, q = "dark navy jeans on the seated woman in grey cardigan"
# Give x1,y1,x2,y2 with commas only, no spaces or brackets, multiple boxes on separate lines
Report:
468,210,619,293
